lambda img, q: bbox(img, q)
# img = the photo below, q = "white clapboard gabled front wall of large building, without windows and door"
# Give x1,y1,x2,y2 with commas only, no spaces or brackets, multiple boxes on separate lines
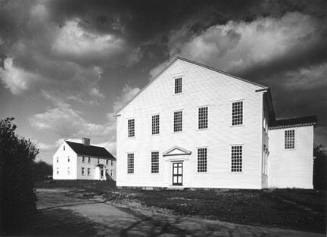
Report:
117,57,263,189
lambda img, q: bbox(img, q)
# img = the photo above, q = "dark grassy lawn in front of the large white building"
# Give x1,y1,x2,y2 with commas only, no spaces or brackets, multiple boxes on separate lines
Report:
37,181,326,233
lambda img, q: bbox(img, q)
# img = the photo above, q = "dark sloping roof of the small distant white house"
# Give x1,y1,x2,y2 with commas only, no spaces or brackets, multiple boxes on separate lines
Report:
65,141,116,160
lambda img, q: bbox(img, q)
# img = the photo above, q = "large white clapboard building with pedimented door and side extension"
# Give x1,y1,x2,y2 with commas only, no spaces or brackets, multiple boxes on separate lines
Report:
116,57,316,189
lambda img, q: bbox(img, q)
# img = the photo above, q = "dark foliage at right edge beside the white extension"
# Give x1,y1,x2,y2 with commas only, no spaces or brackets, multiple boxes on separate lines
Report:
313,145,327,190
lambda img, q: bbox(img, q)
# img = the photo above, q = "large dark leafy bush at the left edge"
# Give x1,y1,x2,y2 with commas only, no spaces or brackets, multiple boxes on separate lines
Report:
0,118,38,234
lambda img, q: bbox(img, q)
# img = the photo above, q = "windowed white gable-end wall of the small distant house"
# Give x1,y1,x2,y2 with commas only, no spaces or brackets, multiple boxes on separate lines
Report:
52,142,77,179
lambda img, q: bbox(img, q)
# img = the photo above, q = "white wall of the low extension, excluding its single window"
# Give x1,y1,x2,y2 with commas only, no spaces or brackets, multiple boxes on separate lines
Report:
268,126,314,189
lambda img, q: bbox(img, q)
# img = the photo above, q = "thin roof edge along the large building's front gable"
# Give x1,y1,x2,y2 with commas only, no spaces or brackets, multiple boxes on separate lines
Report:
115,56,269,116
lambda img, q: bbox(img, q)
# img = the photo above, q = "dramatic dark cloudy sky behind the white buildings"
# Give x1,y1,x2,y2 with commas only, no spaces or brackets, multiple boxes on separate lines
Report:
0,0,327,162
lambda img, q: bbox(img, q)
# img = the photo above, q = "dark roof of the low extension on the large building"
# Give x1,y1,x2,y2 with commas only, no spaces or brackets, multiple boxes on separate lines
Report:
269,116,318,129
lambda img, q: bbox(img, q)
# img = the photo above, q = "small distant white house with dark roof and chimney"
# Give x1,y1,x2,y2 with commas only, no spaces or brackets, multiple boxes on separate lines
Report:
52,138,116,180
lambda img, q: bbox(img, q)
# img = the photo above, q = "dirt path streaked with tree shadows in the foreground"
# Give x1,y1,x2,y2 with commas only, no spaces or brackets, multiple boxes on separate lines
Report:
37,189,324,237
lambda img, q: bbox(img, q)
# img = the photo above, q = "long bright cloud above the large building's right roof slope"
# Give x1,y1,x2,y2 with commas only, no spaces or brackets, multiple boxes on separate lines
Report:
164,12,321,73
